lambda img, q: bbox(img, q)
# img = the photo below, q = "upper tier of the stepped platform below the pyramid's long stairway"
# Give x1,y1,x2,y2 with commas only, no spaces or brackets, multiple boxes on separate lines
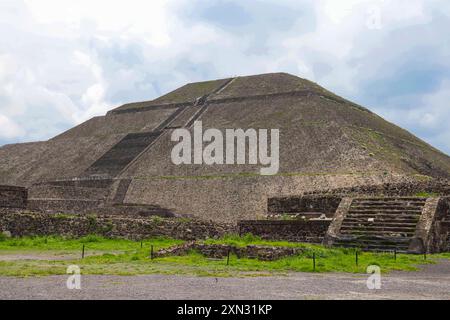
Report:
28,185,109,200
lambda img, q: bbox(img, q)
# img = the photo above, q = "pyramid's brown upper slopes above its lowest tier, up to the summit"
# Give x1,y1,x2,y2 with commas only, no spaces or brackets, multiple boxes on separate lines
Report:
0,73,450,185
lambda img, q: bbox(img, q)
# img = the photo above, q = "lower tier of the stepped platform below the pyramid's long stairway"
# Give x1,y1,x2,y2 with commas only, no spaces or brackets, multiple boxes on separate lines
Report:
27,199,103,214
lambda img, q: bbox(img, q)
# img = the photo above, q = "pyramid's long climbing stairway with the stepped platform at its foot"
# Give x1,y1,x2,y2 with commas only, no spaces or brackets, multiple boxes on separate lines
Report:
24,80,237,216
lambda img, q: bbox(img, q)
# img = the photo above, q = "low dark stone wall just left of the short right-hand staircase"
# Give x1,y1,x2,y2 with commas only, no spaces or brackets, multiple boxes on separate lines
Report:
238,220,331,243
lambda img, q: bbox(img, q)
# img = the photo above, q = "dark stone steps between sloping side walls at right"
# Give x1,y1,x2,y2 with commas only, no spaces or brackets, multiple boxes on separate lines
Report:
333,198,426,252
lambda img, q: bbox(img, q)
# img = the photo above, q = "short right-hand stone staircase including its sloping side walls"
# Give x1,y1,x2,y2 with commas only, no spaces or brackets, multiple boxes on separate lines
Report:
324,197,450,254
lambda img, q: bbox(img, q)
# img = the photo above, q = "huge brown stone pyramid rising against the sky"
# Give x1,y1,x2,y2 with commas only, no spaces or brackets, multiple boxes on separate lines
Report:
0,73,450,220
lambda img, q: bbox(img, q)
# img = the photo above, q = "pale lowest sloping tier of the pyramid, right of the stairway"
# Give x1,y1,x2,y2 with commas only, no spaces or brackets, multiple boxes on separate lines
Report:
124,172,414,223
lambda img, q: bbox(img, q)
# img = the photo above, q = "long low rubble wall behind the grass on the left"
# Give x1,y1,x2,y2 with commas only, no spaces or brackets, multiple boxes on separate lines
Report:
0,209,236,240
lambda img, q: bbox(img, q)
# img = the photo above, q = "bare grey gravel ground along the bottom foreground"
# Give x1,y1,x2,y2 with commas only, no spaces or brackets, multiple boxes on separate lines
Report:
0,261,450,300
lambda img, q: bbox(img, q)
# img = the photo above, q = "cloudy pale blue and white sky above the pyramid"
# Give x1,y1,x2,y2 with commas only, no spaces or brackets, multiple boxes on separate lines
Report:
0,0,450,154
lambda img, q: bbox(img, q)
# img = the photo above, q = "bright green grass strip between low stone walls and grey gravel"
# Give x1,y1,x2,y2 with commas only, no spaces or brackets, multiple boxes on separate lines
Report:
0,235,450,277
